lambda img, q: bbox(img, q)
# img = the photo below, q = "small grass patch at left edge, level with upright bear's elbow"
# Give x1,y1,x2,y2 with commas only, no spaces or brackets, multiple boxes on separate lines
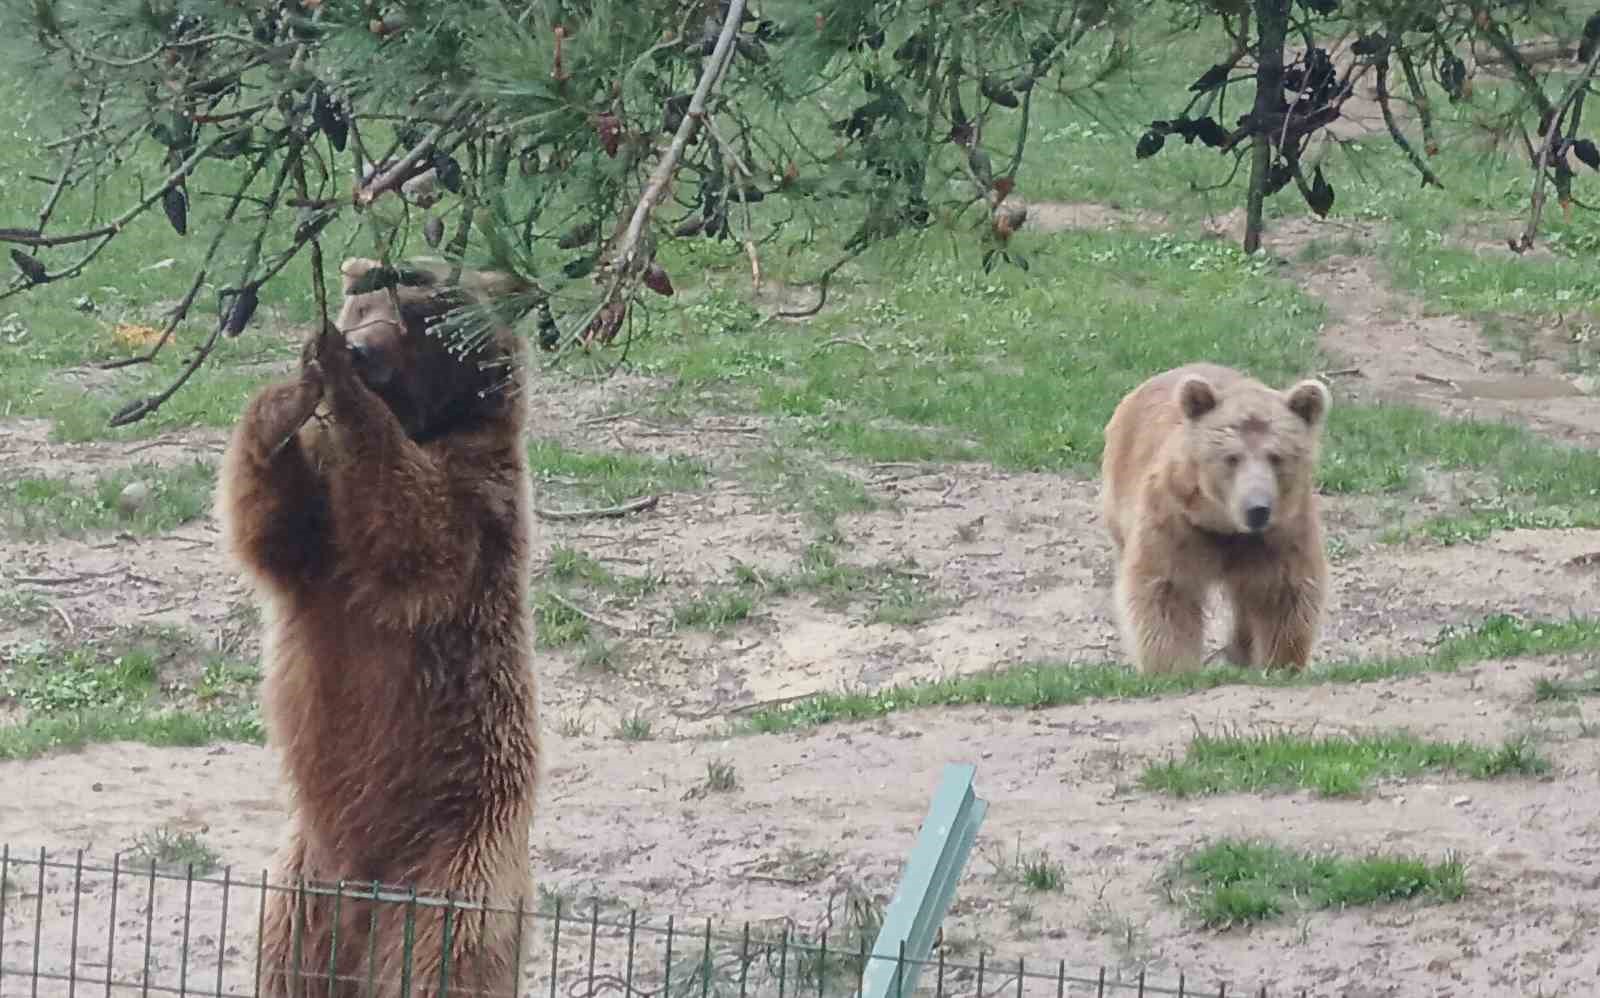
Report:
0,461,216,537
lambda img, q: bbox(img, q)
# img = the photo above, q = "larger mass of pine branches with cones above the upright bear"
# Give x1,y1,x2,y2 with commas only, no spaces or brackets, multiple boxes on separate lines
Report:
0,0,1123,422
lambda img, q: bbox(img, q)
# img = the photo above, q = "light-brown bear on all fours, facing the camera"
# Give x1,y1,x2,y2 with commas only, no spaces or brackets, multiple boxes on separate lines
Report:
1101,363,1333,673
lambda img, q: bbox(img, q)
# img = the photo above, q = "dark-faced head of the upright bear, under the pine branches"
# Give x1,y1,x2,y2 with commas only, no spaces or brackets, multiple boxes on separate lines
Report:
336,257,526,440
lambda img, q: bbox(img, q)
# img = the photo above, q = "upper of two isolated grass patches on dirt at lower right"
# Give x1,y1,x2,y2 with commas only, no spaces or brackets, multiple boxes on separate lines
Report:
1139,731,1550,798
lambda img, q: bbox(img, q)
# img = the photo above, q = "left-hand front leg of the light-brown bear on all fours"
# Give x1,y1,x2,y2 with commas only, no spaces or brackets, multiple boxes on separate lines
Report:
1117,542,1205,675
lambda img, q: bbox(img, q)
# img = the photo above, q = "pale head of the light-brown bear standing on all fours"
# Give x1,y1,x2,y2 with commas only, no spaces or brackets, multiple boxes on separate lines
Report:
1176,374,1333,534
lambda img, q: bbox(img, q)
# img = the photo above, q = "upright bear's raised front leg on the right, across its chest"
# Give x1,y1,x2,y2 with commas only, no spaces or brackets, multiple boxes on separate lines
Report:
308,328,478,629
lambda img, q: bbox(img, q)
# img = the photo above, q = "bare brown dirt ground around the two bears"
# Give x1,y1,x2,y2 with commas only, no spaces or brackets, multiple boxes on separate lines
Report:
0,205,1600,998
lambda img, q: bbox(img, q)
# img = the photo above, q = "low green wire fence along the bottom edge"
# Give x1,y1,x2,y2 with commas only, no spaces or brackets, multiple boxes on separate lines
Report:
0,846,1299,998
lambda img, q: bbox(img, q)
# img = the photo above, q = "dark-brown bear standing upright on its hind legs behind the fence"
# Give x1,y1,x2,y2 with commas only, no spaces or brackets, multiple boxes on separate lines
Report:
218,259,541,998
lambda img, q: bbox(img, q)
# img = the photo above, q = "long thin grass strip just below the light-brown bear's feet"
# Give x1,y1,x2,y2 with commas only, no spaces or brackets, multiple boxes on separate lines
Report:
734,614,1600,733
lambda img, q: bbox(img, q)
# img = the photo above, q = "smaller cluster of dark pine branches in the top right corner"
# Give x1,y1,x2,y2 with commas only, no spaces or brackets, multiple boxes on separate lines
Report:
1134,0,1600,251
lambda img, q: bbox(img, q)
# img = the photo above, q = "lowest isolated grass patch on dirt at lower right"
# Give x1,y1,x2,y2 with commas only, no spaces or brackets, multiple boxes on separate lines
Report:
1173,838,1467,929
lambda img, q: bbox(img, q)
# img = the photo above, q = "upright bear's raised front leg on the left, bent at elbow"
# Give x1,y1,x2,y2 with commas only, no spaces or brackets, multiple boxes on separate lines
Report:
218,365,326,587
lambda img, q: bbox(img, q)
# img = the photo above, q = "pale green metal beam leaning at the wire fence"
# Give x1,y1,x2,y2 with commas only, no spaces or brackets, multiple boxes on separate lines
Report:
861,764,989,998
